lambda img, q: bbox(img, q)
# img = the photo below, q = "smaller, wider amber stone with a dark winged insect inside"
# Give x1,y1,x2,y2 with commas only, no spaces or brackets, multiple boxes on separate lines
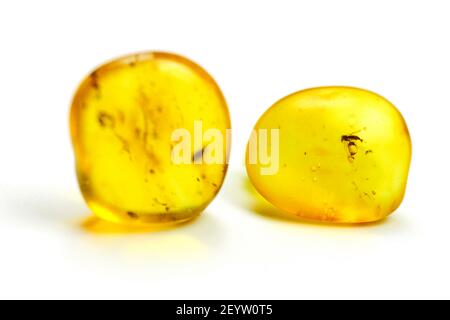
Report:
246,87,411,223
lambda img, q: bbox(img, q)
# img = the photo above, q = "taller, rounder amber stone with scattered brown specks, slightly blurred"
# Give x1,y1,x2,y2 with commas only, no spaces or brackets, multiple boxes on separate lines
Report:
70,52,230,225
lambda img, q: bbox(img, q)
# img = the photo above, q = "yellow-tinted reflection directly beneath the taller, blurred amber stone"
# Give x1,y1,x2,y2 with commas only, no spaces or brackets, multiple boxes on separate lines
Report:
77,212,224,263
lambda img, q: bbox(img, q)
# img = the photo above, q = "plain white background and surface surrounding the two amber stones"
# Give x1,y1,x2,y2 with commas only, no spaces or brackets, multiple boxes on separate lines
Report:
0,0,450,299
